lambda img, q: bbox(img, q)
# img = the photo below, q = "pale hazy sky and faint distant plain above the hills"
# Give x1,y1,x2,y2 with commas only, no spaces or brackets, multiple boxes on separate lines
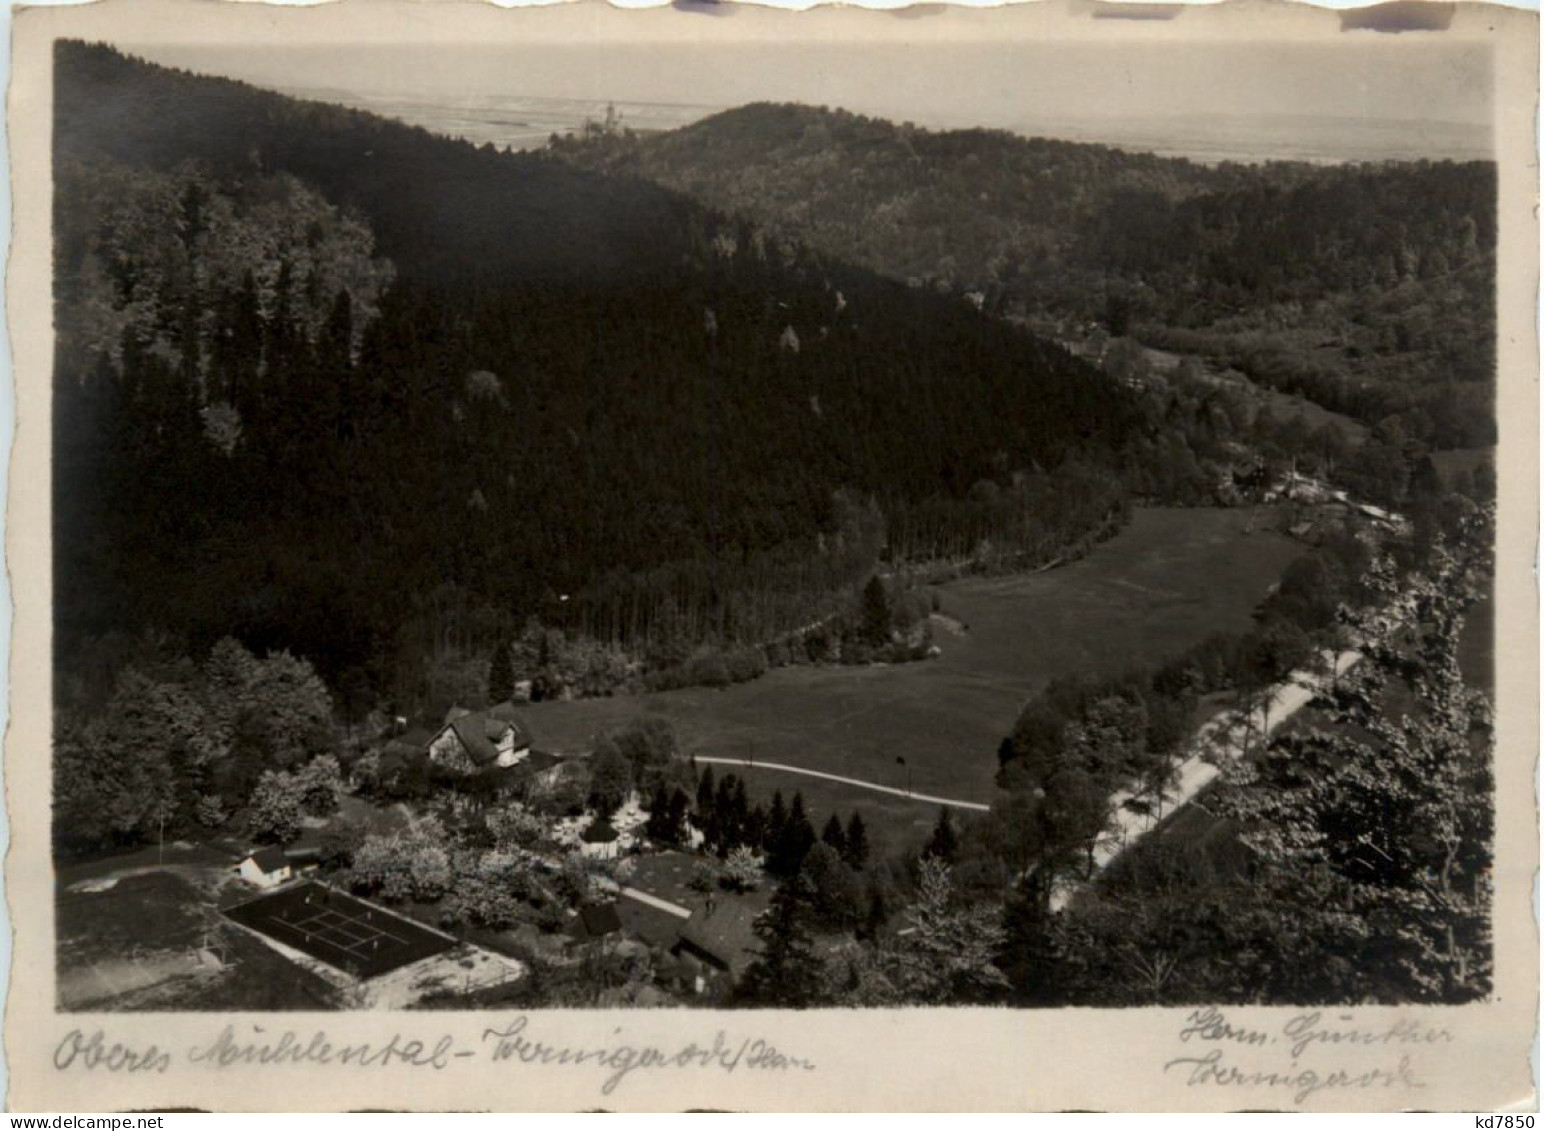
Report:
127,33,1492,138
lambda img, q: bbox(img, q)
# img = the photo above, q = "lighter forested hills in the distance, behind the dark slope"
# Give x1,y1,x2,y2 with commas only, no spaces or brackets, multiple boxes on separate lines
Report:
551,105,1496,447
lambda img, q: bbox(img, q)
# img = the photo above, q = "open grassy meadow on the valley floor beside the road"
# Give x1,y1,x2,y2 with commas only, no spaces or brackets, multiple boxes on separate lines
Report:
527,508,1302,842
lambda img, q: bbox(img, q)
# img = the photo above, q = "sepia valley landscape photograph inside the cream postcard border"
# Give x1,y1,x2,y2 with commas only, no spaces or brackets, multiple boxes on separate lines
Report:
12,3,1536,1106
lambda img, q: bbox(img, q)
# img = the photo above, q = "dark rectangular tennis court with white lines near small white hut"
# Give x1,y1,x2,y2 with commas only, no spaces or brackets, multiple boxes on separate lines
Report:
225,883,455,978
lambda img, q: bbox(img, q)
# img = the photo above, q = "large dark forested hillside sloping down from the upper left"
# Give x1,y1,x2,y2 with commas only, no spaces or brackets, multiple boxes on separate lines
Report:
54,43,1138,715
